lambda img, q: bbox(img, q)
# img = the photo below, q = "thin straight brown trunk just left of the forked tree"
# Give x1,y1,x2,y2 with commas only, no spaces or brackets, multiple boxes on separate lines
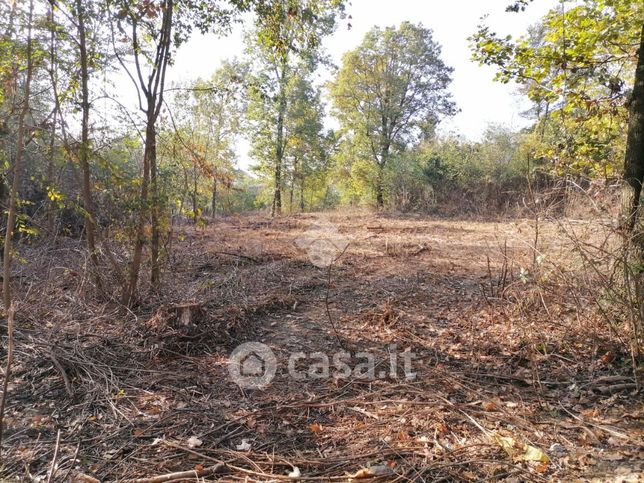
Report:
76,0,101,288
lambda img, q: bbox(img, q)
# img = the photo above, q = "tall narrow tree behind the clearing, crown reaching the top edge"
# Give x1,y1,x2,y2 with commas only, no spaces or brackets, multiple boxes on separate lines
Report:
249,0,344,216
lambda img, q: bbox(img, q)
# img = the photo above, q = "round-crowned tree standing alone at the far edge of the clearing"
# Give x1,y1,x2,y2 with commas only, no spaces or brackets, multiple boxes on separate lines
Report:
330,22,455,208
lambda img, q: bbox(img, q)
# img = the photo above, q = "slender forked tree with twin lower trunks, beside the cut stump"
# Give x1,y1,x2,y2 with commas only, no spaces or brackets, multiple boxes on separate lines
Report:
111,0,250,304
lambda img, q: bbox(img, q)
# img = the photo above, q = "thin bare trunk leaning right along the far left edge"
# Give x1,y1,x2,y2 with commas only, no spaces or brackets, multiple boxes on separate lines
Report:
2,0,34,324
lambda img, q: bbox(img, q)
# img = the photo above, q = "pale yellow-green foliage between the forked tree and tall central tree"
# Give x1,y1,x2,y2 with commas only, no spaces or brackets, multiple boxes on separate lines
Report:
158,60,248,220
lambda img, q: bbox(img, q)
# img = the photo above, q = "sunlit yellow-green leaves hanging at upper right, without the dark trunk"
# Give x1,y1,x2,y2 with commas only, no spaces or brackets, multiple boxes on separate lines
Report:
470,0,644,177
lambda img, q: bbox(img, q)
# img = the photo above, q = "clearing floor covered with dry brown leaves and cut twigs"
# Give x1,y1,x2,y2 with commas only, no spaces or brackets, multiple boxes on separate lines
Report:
0,213,644,482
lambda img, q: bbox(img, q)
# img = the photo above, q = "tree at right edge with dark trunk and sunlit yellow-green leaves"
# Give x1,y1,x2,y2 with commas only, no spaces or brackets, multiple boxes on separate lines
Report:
471,0,644,352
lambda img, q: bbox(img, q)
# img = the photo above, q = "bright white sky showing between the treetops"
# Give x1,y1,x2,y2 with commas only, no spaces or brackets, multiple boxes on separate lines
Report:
161,0,556,167
